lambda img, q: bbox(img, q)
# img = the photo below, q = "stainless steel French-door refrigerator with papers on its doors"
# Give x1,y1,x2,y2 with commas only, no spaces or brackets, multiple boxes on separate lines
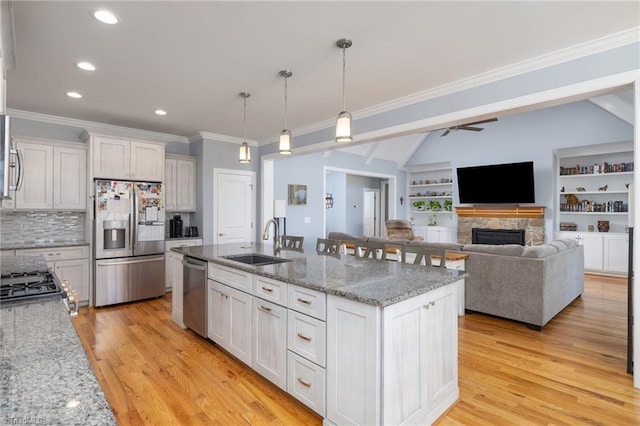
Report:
94,179,165,306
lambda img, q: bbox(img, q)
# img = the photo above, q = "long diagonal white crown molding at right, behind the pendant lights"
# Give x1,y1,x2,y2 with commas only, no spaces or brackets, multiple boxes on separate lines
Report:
259,27,640,144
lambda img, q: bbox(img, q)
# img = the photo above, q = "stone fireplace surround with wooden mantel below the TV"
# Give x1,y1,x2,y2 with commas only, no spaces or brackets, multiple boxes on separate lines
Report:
456,206,544,246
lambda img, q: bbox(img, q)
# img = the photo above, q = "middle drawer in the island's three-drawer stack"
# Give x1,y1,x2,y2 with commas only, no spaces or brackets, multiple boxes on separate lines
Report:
287,311,327,367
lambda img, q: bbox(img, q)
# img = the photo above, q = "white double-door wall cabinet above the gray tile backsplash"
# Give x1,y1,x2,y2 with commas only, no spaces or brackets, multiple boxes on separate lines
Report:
6,139,87,210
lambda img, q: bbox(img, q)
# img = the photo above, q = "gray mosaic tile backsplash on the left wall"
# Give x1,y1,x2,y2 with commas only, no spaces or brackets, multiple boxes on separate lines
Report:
0,211,85,245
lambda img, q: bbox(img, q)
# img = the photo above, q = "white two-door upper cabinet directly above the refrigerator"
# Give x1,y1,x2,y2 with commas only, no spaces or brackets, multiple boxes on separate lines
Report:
90,135,164,182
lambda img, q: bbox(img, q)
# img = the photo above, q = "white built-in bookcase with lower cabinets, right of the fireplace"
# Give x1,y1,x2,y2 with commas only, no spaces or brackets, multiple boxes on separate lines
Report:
555,141,634,274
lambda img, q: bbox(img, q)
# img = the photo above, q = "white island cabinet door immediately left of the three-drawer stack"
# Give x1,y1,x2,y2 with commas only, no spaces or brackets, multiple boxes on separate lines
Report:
251,297,287,390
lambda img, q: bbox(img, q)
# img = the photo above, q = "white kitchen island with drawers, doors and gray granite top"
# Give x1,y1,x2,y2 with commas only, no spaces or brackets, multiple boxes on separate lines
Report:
174,243,467,425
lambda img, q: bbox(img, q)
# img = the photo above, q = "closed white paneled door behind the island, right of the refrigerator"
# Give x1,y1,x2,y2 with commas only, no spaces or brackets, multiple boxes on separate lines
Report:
213,169,255,244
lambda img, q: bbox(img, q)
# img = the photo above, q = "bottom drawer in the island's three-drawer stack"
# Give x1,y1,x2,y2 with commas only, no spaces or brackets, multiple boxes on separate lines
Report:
287,351,326,417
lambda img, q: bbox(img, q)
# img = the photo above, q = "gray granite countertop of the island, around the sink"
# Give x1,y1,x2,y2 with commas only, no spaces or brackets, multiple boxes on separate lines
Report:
178,242,469,307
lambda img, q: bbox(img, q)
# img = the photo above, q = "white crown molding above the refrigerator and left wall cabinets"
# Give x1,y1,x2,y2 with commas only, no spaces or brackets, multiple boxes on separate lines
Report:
7,108,189,143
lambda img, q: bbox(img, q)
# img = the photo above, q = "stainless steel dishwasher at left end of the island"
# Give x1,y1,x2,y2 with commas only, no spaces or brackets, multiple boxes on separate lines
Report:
182,256,207,338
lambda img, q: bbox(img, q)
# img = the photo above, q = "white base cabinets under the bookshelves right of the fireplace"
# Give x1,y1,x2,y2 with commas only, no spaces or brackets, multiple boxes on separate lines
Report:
557,232,629,275
